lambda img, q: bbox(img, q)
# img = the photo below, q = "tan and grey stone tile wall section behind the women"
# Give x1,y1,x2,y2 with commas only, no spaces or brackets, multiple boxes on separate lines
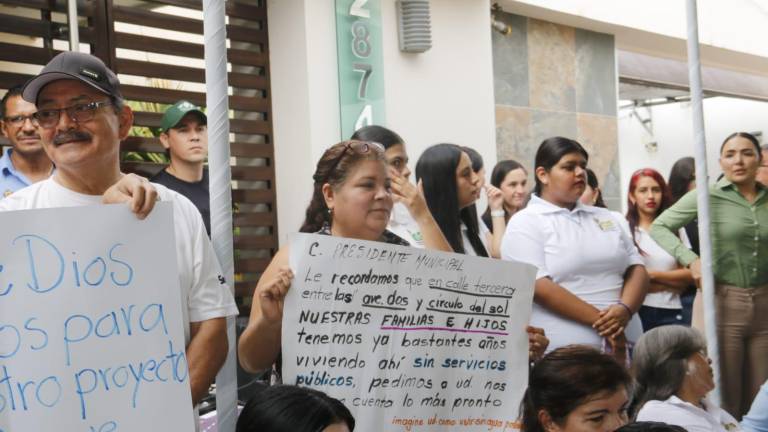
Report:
496,13,621,209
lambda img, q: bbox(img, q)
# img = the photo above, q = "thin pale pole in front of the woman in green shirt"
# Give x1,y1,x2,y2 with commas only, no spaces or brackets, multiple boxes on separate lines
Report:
686,0,721,405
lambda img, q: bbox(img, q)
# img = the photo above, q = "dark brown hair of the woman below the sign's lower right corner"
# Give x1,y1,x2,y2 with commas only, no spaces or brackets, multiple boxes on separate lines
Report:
520,345,632,432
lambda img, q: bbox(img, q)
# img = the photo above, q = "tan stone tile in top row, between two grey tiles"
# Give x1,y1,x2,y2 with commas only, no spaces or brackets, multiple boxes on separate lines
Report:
528,19,576,111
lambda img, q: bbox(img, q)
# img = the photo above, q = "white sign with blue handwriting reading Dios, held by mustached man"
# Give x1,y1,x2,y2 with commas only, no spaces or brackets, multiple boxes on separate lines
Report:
0,203,194,432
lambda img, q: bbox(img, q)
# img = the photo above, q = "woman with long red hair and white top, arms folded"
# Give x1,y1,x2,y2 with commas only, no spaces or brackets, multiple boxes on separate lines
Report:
627,168,693,332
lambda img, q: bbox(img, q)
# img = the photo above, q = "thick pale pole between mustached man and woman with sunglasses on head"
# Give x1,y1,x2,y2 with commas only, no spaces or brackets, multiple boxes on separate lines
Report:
203,0,237,432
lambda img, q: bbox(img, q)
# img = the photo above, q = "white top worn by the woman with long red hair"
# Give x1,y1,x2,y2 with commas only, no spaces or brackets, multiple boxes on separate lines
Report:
635,227,691,309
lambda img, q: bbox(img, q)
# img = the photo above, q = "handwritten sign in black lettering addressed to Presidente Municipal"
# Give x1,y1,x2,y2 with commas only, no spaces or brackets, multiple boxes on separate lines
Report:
282,234,536,431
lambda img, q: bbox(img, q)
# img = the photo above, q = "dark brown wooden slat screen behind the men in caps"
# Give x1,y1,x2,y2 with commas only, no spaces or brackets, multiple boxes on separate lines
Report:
0,0,278,313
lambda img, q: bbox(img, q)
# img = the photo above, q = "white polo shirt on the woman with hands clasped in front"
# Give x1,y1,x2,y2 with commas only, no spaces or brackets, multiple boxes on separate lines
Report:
501,195,643,351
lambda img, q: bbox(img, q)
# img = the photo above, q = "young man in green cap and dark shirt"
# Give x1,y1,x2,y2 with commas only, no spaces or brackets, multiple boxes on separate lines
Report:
150,100,211,236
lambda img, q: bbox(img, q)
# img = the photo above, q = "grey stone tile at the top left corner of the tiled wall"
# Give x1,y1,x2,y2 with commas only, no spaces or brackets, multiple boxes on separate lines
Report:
491,13,528,106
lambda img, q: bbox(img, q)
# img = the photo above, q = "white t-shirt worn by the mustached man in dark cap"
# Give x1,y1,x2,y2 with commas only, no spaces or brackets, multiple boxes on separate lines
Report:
0,178,238,344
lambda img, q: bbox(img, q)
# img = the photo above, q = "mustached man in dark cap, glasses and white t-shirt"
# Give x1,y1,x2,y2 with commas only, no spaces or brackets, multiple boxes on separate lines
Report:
0,52,238,412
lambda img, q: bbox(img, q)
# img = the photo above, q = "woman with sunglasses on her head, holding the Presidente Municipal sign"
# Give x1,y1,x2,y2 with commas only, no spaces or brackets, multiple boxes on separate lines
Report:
238,141,432,371
